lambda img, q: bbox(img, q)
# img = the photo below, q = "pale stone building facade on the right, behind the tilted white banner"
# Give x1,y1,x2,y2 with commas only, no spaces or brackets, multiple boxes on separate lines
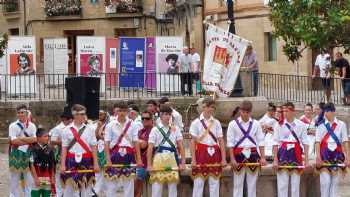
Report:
204,0,316,75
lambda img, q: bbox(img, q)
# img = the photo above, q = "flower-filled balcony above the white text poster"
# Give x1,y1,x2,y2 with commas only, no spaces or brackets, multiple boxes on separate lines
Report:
44,0,82,17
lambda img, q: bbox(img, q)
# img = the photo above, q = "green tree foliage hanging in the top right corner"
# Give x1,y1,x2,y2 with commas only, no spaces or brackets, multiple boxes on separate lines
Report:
269,0,350,62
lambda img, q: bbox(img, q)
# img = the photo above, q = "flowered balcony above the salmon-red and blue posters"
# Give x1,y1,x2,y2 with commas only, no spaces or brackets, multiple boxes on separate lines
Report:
105,0,143,14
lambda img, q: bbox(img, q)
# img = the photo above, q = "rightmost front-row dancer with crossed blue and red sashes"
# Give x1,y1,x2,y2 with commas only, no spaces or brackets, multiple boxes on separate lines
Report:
316,103,349,197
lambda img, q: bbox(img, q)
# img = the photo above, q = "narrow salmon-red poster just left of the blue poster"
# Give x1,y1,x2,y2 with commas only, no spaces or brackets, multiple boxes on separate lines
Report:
106,38,118,87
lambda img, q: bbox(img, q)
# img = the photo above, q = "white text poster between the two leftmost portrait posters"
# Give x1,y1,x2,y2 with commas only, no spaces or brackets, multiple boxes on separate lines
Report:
44,38,68,86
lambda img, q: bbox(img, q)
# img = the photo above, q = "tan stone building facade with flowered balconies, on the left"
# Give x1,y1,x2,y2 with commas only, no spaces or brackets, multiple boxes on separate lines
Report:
0,0,183,73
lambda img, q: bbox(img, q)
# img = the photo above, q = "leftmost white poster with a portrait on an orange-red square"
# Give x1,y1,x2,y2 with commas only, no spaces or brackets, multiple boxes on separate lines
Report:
6,36,38,96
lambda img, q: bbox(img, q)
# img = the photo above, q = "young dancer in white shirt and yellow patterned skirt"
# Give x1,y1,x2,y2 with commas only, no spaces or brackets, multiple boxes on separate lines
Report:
147,105,185,197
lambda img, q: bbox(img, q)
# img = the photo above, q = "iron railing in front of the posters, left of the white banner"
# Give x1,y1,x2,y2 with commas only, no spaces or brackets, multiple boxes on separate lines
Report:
0,73,201,100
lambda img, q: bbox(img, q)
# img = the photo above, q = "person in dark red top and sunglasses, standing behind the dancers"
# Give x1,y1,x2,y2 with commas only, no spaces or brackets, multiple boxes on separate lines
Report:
135,111,153,197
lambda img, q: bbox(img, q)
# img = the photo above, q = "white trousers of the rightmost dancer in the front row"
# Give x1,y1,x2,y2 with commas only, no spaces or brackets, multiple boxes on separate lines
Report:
320,172,340,197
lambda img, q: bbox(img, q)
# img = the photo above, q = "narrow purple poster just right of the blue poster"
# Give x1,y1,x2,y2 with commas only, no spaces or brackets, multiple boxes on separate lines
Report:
145,37,156,90
